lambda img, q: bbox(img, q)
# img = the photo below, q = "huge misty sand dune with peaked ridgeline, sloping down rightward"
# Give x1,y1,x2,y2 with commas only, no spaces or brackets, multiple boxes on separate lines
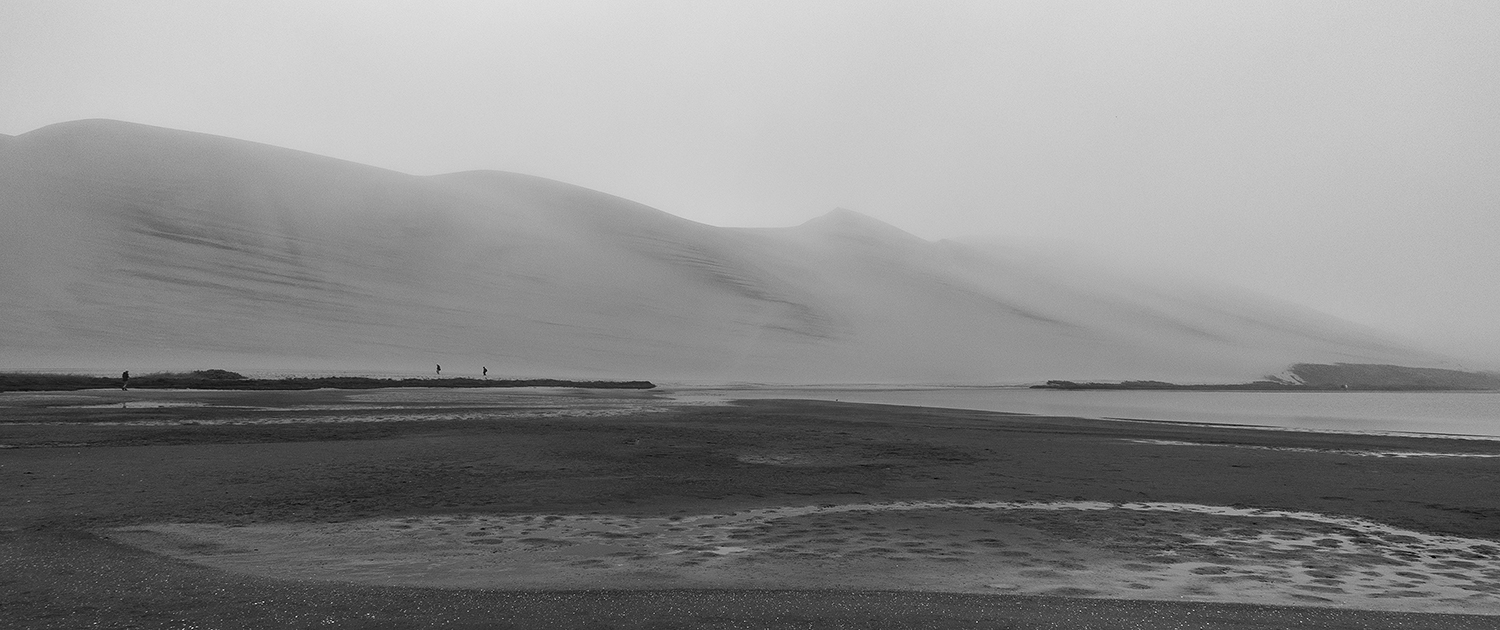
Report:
0,120,1440,383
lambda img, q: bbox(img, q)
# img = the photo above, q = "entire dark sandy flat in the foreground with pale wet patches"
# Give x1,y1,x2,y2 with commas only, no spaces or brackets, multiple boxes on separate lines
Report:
0,389,1500,629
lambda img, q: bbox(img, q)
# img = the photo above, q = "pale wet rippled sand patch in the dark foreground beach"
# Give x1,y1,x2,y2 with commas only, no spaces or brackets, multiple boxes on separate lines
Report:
110,501,1500,615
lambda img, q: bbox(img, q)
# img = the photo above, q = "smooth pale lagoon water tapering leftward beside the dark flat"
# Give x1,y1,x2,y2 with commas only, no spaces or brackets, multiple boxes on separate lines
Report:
696,387,1500,440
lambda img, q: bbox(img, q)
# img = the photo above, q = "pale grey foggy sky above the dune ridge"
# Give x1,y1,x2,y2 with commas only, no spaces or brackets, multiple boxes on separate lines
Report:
0,0,1500,366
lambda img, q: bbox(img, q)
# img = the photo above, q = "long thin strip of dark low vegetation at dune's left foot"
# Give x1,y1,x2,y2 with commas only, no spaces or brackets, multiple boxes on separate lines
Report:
0,369,656,392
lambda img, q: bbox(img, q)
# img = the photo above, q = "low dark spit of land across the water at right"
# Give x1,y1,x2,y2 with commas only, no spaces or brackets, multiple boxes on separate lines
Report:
1032,363,1500,392
